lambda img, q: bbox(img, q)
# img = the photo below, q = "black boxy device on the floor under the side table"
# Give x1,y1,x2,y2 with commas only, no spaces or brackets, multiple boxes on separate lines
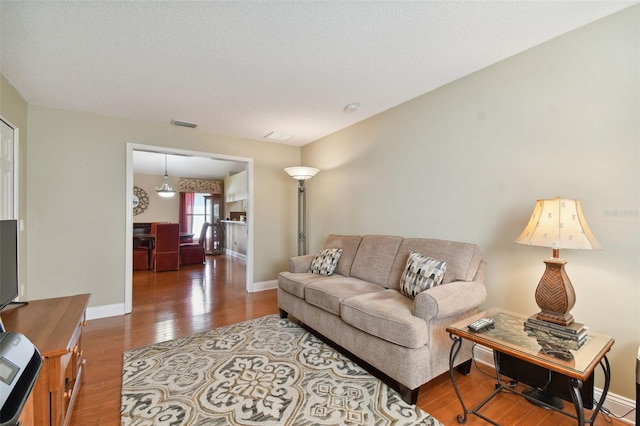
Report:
497,352,593,410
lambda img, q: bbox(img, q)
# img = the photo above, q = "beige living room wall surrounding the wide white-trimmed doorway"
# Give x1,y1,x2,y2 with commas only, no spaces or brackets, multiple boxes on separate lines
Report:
26,105,300,306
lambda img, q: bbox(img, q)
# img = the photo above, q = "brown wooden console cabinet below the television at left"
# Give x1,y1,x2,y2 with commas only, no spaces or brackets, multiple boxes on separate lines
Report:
1,294,90,426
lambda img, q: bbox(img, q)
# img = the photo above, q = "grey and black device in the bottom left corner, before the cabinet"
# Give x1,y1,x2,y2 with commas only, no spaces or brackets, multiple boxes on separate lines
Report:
0,332,42,426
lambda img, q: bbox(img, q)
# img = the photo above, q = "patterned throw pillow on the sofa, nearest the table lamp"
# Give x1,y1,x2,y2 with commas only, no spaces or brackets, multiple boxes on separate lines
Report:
400,251,447,299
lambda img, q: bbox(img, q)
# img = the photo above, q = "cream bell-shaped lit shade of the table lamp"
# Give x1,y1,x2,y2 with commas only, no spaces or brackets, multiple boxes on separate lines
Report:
515,197,602,250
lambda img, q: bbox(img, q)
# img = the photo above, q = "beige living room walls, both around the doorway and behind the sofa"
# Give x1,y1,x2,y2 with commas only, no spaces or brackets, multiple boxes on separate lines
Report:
0,6,640,397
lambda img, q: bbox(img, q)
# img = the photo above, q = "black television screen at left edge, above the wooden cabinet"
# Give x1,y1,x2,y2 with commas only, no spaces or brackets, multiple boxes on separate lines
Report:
0,220,18,309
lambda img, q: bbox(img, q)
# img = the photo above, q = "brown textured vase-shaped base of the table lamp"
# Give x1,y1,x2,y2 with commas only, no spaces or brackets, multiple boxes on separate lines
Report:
536,257,576,326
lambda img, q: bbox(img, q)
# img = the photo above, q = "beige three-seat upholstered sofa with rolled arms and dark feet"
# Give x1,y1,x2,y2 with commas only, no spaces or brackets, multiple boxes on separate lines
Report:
278,235,486,404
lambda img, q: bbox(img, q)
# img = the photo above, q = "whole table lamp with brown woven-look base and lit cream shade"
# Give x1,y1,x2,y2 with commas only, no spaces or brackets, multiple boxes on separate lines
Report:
515,197,602,326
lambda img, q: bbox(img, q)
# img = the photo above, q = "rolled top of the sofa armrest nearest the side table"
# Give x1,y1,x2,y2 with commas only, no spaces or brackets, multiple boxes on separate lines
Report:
413,281,487,323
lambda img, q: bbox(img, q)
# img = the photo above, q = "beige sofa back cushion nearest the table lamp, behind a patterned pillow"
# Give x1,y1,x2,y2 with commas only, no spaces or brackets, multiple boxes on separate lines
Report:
387,238,482,290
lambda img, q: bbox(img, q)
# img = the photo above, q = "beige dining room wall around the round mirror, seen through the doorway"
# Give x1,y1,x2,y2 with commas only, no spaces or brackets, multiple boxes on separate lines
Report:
133,174,180,223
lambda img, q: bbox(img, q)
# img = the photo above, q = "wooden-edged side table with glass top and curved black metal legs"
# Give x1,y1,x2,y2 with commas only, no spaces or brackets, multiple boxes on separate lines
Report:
447,308,614,425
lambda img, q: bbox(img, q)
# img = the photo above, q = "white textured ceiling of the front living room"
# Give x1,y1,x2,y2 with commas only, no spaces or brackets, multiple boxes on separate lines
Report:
0,1,638,145
